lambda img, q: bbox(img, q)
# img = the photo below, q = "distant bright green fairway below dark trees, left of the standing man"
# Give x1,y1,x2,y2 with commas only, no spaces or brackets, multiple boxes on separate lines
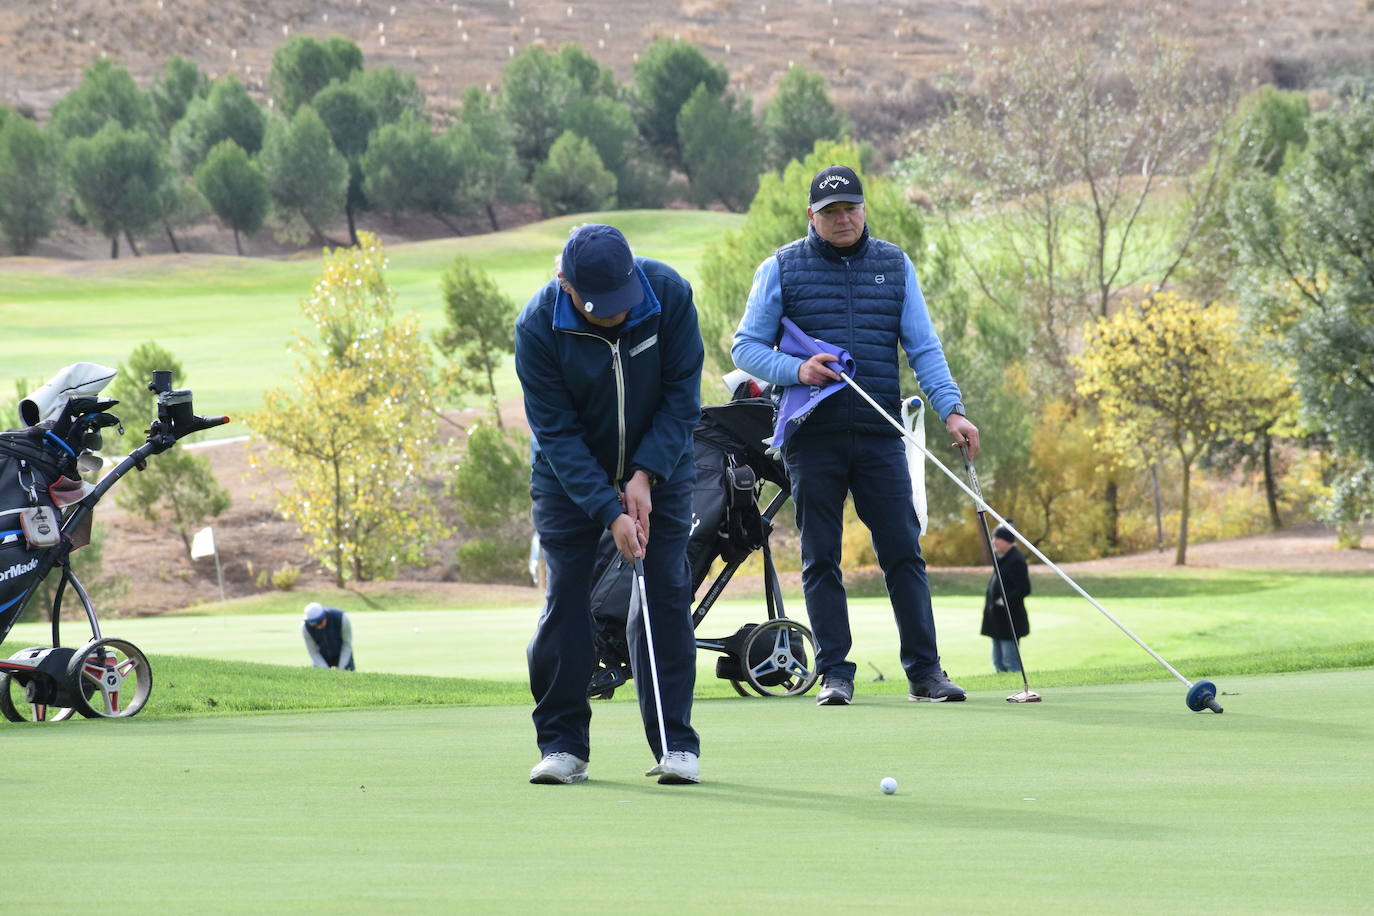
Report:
0,210,743,437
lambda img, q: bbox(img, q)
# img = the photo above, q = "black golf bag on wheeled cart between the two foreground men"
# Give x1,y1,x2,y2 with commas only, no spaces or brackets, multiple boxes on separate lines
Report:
588,397,816,699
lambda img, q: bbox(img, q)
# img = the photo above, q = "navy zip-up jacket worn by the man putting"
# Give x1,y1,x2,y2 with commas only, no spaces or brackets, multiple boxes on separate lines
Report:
515,258,705,527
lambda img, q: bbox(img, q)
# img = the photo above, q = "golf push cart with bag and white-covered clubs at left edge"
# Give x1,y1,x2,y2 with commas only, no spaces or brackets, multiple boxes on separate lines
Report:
0,363,229,722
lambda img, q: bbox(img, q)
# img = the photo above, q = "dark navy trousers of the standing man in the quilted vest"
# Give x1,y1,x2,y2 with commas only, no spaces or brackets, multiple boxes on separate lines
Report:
783,426,940,680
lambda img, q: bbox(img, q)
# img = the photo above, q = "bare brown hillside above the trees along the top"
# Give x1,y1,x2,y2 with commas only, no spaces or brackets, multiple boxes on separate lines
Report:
0,0,1374,138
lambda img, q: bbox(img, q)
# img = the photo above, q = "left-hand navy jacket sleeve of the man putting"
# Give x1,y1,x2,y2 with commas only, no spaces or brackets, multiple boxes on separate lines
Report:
515,317,622,527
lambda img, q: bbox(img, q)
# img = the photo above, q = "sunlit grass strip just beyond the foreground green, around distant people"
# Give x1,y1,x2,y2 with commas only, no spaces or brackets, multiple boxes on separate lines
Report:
13,570,1374,689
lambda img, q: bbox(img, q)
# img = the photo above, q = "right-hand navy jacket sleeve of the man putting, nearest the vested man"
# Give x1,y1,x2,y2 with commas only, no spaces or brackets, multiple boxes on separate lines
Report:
629,273,706,481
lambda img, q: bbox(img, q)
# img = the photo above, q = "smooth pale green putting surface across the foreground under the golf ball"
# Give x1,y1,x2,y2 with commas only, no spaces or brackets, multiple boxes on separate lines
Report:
0,669,1374,913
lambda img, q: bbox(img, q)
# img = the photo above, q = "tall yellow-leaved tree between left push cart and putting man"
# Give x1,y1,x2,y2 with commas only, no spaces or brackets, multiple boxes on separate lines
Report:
247,232,445,586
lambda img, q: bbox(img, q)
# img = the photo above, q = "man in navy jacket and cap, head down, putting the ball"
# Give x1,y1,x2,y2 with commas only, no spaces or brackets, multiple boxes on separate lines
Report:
515,225,702,783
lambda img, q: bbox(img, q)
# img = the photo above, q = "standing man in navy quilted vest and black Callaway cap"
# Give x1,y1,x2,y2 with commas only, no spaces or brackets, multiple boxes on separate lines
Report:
732,165,978,706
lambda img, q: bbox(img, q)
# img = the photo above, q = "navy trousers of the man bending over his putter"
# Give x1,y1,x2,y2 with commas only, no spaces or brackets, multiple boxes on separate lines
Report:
526,477,701,761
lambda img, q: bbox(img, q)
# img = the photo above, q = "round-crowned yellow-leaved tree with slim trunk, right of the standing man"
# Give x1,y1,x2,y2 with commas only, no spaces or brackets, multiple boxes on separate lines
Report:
1073,293,1272,566
